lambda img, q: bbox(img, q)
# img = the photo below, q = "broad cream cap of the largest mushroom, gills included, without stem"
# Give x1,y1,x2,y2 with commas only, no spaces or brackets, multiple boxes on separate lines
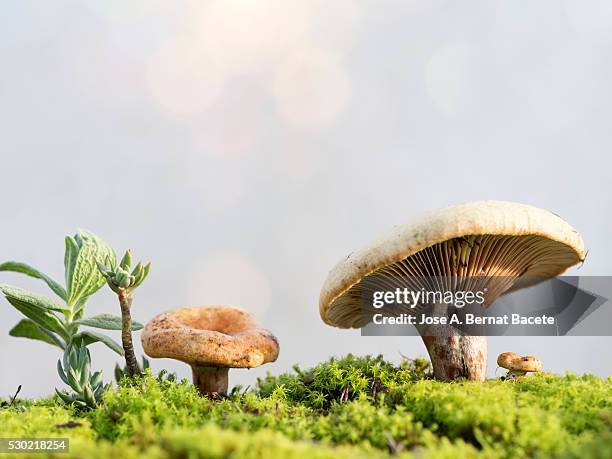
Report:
319,201,586,328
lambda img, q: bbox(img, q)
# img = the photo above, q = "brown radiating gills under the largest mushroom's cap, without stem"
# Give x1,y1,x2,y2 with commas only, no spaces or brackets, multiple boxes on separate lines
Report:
327,234,580,328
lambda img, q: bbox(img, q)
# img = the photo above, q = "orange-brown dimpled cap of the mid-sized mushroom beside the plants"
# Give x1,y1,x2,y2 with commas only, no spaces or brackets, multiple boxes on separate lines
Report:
141,306,279,368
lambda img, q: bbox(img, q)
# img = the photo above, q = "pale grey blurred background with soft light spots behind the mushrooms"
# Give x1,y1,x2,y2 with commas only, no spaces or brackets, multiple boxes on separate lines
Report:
0,0,612,397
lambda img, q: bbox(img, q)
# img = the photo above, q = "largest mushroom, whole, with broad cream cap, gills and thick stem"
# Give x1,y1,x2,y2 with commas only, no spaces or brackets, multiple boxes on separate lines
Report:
319,201,586,381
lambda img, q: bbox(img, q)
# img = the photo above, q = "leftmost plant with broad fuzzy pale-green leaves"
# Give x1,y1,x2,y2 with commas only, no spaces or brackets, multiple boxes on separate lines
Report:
0,230,142,355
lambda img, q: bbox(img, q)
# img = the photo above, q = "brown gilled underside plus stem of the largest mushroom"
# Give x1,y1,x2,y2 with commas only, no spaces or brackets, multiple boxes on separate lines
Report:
325,235,580,381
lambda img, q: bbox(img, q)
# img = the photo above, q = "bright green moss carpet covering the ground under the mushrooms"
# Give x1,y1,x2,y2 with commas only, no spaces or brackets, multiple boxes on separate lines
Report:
0,356,612,459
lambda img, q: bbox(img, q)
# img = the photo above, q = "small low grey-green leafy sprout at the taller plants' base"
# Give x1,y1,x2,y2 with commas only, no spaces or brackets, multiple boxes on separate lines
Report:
55,344,108,408
